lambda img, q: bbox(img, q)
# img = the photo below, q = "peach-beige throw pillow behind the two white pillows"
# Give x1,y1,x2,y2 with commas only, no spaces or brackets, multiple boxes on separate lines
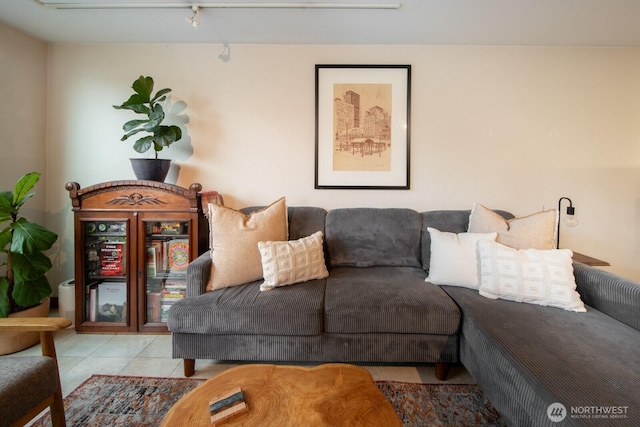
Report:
469,203,557,249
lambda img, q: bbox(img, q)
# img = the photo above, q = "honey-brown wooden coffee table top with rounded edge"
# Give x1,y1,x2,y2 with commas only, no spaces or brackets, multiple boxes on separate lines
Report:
162,363,402,427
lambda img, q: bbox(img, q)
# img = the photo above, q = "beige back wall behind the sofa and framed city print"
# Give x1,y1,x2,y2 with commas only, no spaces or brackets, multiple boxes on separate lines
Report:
37,44,640,286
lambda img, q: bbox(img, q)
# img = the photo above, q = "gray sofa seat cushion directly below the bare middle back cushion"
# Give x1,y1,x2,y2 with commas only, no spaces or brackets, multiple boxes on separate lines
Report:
324,267,460,335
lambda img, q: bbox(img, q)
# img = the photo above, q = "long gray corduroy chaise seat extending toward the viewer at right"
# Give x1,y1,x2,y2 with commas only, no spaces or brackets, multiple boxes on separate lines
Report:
443,286,640,425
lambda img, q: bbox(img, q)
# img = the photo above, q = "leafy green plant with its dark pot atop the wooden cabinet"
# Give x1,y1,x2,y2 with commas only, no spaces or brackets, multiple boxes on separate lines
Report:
113,76,182,182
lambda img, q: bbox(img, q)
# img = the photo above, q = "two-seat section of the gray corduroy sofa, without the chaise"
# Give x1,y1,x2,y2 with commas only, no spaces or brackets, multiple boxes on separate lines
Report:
168,207,469,378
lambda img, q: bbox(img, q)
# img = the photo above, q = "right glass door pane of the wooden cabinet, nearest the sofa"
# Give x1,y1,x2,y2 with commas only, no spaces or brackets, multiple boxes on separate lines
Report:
145,221,190,323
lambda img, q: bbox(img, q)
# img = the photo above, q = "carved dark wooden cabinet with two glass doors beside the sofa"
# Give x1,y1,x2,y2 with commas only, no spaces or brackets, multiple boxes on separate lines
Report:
65,181,208,332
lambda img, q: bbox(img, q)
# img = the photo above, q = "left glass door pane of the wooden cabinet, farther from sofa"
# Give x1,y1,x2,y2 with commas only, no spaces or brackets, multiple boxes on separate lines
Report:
83,221,128,324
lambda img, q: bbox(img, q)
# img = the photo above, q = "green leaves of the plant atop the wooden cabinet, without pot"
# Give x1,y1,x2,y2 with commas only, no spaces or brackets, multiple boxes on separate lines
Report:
113,76,182,159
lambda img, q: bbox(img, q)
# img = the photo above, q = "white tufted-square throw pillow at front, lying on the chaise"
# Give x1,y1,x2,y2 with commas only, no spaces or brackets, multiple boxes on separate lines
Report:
477,241,586,312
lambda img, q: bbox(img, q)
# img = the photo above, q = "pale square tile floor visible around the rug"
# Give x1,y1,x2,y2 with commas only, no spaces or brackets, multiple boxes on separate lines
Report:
0,313,475,396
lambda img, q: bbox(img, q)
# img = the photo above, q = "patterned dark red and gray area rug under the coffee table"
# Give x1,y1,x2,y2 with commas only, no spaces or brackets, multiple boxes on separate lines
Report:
33,375,506,427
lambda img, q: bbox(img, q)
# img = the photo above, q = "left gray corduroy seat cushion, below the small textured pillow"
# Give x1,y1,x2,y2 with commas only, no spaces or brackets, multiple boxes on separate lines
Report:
167,279,325,335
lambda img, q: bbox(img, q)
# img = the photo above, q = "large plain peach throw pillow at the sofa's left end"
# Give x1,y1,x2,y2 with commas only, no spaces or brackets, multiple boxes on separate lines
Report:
207,197,289,291
